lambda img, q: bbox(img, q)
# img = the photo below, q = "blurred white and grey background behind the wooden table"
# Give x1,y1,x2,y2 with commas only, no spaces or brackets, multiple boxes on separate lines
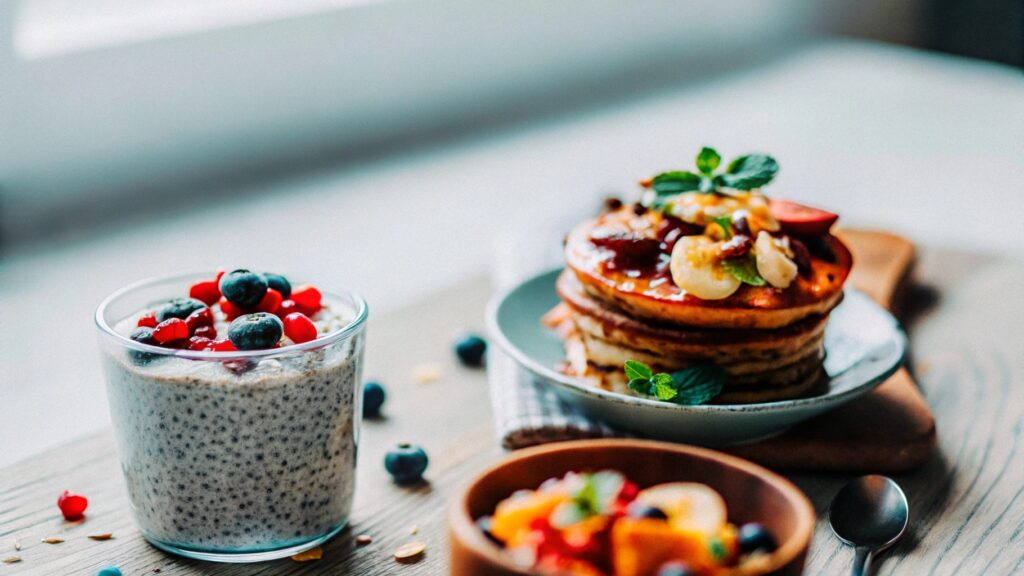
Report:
0,0,1024,465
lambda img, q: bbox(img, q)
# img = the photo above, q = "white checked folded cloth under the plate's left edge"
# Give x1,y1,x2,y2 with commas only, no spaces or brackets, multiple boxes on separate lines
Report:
487,351,629,450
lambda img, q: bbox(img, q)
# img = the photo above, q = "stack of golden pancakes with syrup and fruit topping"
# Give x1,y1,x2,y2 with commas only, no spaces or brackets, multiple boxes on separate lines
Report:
544,193,852,404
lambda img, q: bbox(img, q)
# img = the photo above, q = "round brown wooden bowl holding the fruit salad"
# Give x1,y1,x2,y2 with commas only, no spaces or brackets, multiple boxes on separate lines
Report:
449,440,815,576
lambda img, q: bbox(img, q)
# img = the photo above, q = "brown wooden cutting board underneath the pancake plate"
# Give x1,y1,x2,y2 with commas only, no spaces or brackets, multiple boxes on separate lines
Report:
726,231,937,474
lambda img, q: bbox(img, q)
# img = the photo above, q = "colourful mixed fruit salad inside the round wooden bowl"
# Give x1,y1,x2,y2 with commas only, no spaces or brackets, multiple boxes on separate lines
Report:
477,470,776,576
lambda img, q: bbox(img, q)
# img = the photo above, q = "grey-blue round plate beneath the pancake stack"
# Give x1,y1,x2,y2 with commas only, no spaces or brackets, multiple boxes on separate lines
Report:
487,271,906,446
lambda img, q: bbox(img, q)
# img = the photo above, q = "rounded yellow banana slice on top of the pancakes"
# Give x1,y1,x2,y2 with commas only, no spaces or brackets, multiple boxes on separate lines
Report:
669,236,740,300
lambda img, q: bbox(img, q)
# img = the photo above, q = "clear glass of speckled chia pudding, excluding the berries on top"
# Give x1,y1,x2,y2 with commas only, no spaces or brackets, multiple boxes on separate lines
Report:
97,270,366,561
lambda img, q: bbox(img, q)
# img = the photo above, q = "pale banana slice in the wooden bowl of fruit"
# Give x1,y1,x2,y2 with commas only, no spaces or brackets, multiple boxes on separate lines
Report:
636,482,726,536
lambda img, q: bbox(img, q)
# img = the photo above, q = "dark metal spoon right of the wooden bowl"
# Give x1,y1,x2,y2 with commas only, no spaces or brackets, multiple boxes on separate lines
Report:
828,475,909,576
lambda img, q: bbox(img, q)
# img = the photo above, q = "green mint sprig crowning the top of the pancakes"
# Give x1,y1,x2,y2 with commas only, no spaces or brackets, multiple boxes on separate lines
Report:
650,147,778,196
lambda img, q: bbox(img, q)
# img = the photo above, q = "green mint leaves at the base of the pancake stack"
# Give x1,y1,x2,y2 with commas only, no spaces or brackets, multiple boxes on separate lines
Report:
624,360,726,406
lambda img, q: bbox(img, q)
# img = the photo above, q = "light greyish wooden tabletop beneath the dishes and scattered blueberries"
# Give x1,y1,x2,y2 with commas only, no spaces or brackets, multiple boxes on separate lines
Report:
0,243,1024,576
